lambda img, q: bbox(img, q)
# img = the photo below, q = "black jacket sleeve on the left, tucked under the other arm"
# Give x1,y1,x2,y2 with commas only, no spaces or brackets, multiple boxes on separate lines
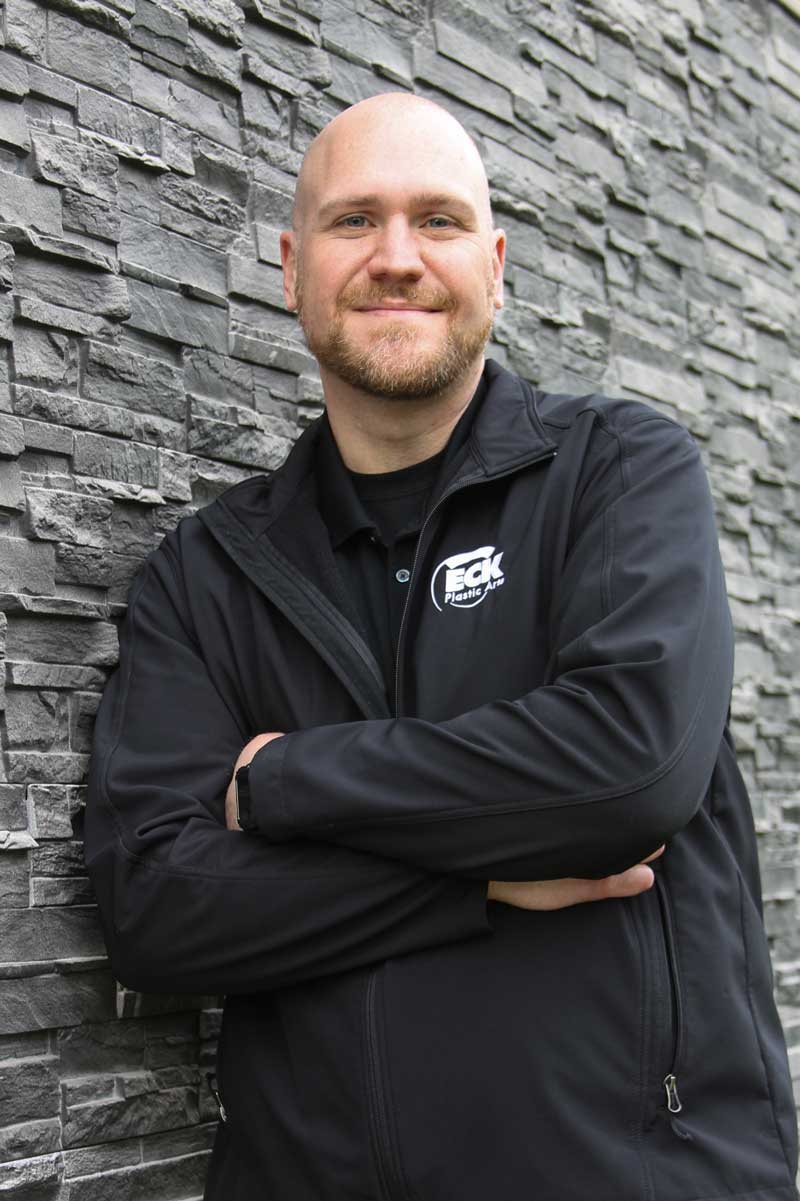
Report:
85,543,491,993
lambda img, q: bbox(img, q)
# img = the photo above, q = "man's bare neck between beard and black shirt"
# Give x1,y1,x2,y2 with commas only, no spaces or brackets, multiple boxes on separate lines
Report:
322,358,484,474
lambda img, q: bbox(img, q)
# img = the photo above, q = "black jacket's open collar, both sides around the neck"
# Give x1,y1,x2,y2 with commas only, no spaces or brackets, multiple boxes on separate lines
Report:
203,359,553,538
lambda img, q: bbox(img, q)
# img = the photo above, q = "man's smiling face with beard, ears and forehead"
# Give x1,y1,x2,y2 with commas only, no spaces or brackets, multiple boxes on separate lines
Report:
281,102,505,399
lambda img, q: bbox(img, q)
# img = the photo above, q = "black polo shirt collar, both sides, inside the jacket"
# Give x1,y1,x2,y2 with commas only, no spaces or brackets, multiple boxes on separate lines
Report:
315,371,488,550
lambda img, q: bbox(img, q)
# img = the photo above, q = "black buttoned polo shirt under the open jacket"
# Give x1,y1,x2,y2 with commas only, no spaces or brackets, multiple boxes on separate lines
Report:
315,377,486,701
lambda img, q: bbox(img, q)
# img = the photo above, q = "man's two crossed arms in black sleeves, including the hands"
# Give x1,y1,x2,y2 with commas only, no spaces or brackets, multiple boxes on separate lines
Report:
85,408,733,993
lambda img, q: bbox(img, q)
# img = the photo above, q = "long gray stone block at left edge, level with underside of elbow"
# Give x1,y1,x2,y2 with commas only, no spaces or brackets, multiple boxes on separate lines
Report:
0,970,115,1034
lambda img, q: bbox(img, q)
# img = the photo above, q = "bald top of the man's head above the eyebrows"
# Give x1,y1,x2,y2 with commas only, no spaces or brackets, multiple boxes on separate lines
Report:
292,91,492,234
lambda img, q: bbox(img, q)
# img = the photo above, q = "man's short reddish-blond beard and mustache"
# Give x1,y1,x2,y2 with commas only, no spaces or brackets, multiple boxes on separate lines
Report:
295,273,495,400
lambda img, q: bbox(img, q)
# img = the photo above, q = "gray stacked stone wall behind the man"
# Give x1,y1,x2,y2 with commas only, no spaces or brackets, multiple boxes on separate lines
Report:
0,0,800,1201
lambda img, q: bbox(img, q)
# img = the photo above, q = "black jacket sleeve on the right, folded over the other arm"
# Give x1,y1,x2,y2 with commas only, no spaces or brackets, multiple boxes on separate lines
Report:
250,410,733,879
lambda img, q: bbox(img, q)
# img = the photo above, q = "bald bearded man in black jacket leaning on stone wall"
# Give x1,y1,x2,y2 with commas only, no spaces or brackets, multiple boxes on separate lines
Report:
86,95,796,1201
